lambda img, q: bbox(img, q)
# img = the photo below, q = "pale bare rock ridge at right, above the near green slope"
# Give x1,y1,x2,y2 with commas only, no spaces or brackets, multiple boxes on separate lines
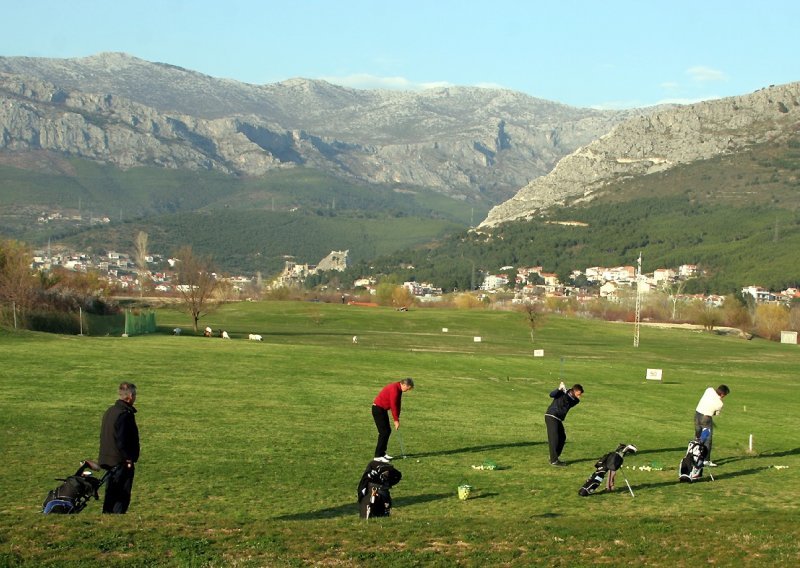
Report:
481,83,800,227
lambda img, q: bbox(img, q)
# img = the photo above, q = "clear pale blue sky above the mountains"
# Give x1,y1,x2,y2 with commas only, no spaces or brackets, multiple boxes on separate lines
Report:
0,0,800,108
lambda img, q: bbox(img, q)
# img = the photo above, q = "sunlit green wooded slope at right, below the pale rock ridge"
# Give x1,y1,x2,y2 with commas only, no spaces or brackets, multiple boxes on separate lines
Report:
342,135,800,293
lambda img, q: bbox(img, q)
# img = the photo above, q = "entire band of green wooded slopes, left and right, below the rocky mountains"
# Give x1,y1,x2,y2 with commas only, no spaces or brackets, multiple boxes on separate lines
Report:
0,137,800,293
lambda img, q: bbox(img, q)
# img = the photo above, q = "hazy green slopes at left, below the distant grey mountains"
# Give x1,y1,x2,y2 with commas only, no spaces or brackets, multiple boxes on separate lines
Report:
0,158,488,273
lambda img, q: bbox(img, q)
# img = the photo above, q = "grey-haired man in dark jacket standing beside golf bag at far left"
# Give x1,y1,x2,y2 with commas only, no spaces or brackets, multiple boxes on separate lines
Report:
97,382,139,514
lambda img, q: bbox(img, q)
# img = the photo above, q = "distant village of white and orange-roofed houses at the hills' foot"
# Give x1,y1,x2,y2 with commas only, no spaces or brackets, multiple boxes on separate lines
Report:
32,243,800,306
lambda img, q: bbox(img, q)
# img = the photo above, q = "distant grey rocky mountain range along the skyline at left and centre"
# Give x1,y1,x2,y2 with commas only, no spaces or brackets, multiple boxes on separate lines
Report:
0,53,636,205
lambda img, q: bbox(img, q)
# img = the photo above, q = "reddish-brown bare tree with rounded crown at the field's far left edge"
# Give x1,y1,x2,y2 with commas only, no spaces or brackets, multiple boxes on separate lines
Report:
175,246,219,333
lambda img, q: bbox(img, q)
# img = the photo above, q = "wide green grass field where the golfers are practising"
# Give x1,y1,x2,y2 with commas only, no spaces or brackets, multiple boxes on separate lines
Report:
0,302,800,566
